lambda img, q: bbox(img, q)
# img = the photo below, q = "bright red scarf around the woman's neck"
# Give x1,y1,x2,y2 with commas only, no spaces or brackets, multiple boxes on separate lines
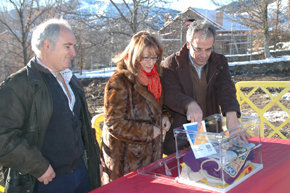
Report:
138,65,162,101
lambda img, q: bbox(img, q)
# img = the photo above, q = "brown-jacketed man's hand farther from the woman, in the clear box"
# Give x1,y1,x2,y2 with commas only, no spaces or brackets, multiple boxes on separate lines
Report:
226,111,250,147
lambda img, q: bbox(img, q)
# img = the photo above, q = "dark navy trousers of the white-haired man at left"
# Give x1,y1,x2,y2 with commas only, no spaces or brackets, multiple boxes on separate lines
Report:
34,163,90,193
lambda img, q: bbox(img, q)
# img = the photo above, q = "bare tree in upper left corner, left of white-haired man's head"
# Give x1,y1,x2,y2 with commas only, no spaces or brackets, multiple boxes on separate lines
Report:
0,0,61,65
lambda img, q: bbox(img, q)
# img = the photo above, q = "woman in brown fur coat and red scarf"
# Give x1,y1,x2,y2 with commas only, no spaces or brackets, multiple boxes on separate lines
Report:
102,31,171,184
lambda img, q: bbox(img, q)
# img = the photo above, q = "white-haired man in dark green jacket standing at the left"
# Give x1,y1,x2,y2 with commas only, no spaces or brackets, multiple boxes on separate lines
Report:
0,19,100,193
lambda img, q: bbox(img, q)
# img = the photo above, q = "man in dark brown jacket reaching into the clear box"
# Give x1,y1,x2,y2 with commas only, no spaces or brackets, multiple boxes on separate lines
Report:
162,20,246,155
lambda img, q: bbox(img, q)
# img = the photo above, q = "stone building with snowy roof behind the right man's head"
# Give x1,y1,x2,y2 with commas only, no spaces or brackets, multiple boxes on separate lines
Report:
159,7,251,57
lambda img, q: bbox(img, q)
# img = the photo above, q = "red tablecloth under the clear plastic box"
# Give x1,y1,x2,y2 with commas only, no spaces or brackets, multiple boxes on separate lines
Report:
91,138,290,193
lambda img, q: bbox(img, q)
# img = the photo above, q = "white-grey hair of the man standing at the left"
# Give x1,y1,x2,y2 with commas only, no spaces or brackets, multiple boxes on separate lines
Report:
31,18,72,56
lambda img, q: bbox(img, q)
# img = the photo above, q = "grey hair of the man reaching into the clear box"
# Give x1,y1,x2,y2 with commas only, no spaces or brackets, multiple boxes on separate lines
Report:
186,20,216,43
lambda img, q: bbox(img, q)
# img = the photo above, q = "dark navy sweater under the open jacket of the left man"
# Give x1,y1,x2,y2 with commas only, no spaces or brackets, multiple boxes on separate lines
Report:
42,72,84,174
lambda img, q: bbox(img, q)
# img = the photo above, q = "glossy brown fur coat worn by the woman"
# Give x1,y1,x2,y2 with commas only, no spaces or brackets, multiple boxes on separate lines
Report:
102,62,167,184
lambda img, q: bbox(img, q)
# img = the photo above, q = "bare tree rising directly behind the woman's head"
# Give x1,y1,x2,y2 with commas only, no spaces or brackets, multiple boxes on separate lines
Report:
97,0,168,62
